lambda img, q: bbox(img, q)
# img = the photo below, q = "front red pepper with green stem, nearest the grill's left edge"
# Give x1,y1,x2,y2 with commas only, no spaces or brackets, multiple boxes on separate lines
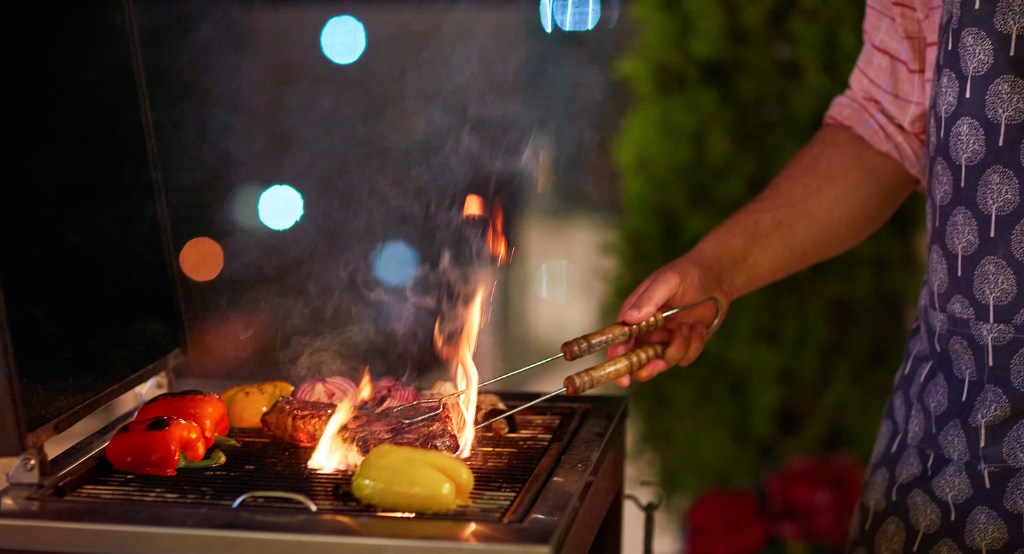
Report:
103,416,224,476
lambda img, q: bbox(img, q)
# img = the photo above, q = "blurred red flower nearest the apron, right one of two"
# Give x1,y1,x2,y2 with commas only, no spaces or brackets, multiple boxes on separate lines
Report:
764,455,864,550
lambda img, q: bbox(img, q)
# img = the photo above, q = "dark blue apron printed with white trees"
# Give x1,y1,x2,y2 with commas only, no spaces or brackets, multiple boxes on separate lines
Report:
849,0,1024,554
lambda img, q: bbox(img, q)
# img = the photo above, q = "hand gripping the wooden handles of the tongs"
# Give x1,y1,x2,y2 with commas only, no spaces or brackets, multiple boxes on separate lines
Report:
608,256,728,387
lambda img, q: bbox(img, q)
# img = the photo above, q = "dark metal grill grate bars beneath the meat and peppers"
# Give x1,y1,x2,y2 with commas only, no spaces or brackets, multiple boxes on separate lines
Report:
65,407,577,520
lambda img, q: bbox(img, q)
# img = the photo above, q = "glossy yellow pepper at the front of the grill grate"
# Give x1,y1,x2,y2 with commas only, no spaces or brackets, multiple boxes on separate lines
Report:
352,444,473,513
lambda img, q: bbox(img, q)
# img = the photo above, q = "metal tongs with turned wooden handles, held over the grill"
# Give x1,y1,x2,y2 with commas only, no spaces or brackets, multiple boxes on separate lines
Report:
392,296,722,429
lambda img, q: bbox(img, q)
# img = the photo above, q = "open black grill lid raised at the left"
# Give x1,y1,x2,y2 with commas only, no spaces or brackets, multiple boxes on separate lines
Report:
0,0,182,456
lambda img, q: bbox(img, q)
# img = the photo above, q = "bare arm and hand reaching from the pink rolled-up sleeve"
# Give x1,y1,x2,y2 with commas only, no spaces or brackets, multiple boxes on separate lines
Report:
608,125,918,386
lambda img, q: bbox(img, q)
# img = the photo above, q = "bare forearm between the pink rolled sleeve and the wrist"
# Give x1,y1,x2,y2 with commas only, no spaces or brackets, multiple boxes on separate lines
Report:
684,126,916,301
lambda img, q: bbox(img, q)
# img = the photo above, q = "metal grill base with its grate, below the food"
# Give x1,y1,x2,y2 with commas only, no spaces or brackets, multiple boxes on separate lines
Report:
0,394,625,553
